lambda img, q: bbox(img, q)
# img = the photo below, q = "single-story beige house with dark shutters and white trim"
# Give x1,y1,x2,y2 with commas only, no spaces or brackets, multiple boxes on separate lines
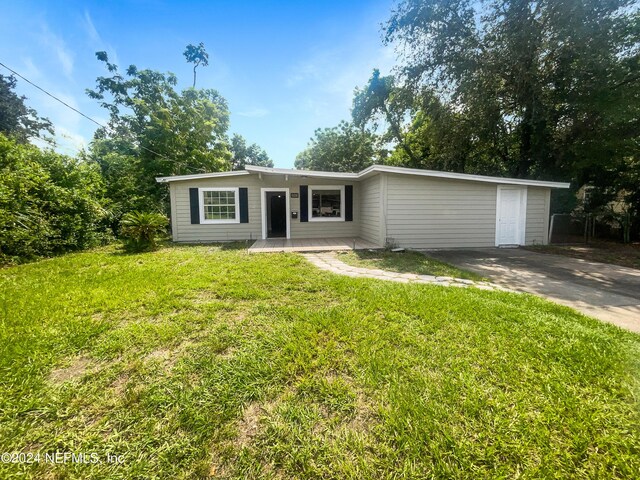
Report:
156,165,569,249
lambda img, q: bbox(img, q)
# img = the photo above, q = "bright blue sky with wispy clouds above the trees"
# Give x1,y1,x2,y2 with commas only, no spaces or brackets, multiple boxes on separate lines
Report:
0,0,396,168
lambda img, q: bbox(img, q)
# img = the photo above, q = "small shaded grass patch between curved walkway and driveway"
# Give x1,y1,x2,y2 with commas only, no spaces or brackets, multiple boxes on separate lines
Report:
338,250,486,281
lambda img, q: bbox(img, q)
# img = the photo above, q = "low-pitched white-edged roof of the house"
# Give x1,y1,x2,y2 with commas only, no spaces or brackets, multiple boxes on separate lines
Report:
156,165,570,188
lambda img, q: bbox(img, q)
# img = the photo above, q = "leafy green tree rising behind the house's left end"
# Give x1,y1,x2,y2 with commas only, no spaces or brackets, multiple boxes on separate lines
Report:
87,52,231,210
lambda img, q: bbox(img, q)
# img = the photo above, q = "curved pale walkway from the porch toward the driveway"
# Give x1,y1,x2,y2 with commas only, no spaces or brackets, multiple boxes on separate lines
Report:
303,252,510,291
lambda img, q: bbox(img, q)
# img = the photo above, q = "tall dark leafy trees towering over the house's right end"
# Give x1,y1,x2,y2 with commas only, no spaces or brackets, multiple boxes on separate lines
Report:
386,0,640,184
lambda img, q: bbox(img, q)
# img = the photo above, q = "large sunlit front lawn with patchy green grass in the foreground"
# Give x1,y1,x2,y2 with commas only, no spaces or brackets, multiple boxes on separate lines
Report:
0,246,640,479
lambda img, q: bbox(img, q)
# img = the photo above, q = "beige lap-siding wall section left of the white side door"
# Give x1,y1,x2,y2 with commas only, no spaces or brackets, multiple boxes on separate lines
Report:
385,174,497,248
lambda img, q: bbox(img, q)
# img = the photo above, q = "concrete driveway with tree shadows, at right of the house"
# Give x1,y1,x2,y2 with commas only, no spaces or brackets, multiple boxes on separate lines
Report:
424,248,640,333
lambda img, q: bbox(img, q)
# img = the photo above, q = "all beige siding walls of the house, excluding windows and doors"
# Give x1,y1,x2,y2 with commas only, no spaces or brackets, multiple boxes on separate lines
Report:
169,173,550,249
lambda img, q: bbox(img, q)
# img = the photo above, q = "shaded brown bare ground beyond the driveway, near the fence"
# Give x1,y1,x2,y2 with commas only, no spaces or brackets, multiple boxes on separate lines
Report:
524,242,640,269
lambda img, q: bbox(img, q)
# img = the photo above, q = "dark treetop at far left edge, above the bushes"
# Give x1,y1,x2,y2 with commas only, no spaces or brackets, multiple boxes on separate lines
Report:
0,75,53,143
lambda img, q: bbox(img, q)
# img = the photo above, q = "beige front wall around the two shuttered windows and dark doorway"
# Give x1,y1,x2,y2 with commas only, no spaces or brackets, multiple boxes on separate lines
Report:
170,175,360,243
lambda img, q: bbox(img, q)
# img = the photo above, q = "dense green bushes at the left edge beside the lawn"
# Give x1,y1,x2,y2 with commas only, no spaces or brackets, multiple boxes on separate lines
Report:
0,134,106,263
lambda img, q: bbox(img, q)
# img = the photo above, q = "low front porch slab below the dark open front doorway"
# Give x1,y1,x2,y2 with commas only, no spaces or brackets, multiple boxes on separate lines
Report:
249,238,380,253
